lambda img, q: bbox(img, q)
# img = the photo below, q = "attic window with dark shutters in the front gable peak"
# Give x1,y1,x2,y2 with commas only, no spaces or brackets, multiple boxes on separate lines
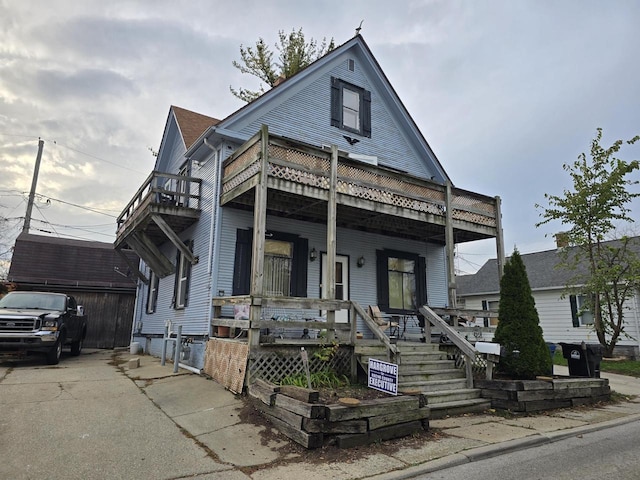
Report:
331,77,371,137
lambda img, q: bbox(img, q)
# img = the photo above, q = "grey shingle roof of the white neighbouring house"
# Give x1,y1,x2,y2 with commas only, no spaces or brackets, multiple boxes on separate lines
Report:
456,237,640,296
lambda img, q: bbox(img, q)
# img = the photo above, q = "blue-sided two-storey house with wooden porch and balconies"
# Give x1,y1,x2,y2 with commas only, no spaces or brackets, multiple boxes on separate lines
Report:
115,35,504,404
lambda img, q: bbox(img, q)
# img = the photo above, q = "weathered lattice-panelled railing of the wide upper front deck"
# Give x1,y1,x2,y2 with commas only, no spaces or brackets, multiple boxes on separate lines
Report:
222,133,498,228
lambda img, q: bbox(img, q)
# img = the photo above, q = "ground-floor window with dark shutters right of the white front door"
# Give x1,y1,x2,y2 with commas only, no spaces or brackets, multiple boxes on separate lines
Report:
377,250,427,313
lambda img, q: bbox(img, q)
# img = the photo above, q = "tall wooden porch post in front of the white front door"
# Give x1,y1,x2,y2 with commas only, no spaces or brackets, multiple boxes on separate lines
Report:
323,145,338,341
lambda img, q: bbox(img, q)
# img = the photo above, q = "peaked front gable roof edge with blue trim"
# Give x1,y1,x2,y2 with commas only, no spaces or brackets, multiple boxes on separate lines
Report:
186,34,451,183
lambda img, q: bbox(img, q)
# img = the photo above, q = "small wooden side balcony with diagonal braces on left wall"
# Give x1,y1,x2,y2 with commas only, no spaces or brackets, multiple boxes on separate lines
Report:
114,172,202,277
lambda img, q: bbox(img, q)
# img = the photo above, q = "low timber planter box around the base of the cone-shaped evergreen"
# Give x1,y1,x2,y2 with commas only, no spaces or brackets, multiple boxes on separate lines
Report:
474,377,611,412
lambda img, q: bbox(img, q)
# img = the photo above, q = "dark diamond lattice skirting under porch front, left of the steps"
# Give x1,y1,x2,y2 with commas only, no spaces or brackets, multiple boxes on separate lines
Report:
248,347,353,384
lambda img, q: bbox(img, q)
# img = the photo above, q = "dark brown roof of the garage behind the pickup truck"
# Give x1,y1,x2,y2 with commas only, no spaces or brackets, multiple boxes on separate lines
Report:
8,233,139,290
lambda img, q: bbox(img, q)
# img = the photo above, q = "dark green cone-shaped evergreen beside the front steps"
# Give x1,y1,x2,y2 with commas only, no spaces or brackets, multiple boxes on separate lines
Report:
493,249,552,380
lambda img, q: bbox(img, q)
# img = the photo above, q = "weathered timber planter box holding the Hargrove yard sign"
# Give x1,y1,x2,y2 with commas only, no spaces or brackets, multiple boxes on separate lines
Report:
248,380,430,449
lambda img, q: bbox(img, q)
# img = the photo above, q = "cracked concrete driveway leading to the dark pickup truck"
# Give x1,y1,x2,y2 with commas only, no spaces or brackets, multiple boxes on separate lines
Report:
0,351,255,480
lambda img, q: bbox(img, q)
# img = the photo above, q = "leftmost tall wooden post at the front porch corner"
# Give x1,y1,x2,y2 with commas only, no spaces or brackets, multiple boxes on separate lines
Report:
247,125,269,350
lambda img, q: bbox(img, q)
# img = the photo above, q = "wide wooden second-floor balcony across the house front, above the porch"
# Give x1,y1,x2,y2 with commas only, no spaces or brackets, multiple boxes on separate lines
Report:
220,128,500,243
